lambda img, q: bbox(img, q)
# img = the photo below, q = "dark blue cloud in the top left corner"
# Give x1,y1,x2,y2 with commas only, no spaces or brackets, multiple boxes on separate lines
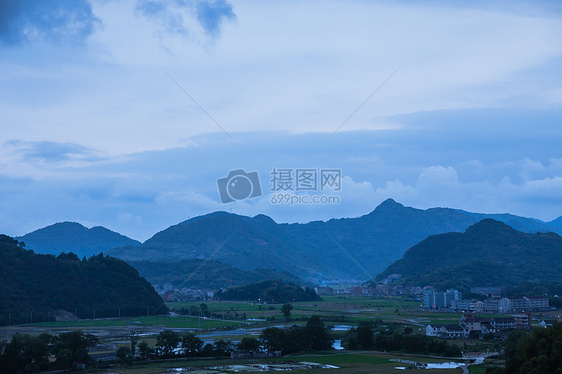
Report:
0,0,101,45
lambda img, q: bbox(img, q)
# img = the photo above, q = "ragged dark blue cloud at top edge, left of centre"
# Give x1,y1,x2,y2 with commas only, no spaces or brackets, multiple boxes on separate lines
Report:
136,0,236,37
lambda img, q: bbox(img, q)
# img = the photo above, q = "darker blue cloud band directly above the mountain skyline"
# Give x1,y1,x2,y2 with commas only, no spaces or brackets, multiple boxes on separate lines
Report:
0,105,562,240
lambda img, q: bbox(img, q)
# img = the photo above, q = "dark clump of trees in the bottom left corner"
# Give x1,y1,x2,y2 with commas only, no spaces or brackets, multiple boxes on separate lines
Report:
0,330,99,374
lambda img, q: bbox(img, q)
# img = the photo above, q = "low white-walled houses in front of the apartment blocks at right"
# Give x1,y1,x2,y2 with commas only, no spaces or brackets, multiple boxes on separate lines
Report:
425,312,557,339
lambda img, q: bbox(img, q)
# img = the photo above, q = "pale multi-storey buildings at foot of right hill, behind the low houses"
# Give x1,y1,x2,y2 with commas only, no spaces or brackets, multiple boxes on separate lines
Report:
423,288,549,313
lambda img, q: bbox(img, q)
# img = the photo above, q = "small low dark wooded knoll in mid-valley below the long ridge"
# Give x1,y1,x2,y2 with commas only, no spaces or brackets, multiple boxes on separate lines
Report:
215,279,322,304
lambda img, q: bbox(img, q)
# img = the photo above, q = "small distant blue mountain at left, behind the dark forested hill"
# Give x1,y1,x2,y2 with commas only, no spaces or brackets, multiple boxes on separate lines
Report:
16,222,141,258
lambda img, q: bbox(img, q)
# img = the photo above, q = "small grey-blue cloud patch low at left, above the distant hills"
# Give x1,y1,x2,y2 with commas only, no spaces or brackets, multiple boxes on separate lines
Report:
5,140,101,162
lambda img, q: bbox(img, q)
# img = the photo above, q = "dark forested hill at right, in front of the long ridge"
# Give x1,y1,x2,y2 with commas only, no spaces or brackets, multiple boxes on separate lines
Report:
377,219,562,288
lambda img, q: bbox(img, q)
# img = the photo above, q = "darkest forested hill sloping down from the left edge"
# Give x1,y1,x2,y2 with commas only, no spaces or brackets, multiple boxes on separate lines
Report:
0,235,167,325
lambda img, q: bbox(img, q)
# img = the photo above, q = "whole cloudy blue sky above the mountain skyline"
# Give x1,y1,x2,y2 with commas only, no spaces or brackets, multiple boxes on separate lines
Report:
0,0,562,241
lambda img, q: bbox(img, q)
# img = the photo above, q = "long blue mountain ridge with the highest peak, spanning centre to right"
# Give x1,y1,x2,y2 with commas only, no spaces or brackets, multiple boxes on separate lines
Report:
107,199,562,281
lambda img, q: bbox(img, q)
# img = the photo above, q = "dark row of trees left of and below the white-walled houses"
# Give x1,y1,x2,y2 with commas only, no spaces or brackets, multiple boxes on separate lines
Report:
342,320,461,357
